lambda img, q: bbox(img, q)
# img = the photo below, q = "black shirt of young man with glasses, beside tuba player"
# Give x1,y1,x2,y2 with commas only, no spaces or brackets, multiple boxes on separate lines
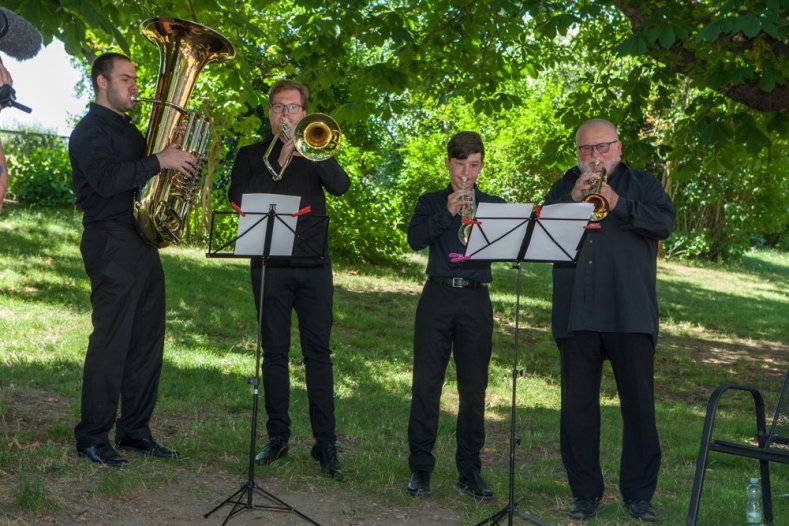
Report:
228,135,351,266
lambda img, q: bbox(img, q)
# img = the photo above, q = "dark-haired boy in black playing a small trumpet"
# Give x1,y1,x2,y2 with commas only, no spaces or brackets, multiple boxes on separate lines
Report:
406,132,503,499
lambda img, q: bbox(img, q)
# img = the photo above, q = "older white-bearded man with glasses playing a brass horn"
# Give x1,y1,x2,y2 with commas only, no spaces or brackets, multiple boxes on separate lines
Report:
545,119,674,522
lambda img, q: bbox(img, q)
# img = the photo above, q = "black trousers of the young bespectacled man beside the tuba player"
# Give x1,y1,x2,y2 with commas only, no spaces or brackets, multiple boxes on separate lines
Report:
252,260,337,444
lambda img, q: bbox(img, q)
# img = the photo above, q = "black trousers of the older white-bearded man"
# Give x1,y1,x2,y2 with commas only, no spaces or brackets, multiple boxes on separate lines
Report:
557,332,661,501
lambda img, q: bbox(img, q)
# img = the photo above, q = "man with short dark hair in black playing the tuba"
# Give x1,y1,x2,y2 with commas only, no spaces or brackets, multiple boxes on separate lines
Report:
69,53,197,467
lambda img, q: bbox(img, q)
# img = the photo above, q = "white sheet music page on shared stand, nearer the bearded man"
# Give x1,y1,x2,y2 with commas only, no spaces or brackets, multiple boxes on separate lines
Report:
523,203,594,261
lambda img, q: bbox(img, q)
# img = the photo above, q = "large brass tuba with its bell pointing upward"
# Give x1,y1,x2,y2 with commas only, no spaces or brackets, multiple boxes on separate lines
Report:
134,18,235,248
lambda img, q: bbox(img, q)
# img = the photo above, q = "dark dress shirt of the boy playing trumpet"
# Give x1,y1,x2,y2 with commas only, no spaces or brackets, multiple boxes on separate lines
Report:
408,184,504,283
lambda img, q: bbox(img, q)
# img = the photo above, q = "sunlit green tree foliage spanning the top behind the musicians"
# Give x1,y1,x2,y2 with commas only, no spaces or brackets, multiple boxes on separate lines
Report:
6,0,789,261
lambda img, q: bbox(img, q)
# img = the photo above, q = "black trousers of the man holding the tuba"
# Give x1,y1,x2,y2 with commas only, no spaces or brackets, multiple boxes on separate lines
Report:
74,222,165,447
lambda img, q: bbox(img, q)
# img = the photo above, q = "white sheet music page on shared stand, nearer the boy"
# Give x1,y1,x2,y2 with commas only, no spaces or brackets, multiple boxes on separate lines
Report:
466,203,534,261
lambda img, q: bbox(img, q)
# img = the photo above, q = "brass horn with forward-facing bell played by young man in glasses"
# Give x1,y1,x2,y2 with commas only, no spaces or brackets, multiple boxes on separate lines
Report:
263,113,342,181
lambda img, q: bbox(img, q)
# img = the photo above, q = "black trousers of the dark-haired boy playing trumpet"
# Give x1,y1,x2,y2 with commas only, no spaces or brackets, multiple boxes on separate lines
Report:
408,281,493,474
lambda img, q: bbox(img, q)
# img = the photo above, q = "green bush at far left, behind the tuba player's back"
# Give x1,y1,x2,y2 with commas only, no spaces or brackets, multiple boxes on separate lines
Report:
4,130,74,207
